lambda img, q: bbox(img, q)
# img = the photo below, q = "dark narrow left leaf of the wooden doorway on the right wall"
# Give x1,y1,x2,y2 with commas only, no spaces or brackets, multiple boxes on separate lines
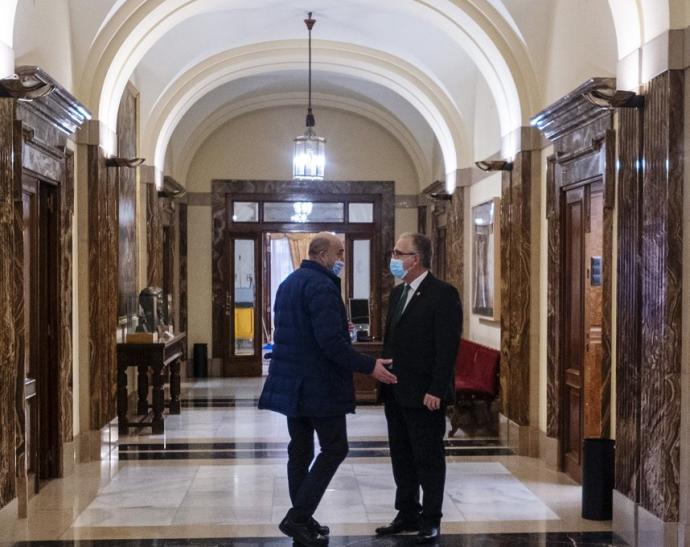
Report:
560,187,585,482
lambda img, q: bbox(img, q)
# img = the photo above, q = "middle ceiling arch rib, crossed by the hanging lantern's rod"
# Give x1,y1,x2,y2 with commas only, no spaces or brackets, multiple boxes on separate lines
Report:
142,40,471,191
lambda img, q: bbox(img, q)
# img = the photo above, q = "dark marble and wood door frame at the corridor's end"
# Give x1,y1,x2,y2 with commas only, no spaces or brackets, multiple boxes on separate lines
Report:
212,180,395,376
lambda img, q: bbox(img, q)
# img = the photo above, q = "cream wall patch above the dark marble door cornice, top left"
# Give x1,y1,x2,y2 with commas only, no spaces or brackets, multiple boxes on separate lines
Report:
14,0,74,91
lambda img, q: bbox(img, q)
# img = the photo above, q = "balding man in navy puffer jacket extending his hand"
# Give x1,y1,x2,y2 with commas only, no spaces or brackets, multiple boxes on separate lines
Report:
259,232,396,547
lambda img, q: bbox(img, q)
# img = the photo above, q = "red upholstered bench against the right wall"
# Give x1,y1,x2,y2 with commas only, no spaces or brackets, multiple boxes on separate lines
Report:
448,339,501,437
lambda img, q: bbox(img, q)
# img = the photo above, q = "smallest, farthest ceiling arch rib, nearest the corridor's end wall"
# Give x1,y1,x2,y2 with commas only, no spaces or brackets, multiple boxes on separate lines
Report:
173,93,431,189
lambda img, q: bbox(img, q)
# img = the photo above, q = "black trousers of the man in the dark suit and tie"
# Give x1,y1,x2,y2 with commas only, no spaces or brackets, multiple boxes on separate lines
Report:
385,399,446,525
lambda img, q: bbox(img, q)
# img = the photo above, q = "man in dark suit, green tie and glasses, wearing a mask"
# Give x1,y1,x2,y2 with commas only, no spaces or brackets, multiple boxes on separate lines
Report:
376,234,462,543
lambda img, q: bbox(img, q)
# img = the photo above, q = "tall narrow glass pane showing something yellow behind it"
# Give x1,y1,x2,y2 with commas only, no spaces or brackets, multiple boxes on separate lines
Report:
233,239,256,355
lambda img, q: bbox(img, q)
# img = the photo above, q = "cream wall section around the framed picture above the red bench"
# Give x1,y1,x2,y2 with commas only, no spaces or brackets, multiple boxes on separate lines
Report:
463,172,501,349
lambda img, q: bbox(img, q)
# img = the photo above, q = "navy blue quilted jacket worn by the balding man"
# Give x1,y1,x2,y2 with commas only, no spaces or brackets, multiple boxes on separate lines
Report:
259,260,374,418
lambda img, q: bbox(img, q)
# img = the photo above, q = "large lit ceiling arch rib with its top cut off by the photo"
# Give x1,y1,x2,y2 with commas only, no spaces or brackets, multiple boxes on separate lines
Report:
78,0,536,170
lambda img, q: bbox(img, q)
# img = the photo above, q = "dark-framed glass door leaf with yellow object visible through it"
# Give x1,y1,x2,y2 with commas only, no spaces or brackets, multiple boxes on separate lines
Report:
224,234,262,376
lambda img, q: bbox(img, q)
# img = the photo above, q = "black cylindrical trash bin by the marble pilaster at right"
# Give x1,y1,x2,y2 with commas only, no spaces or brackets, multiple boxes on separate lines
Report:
582,439,615,520
